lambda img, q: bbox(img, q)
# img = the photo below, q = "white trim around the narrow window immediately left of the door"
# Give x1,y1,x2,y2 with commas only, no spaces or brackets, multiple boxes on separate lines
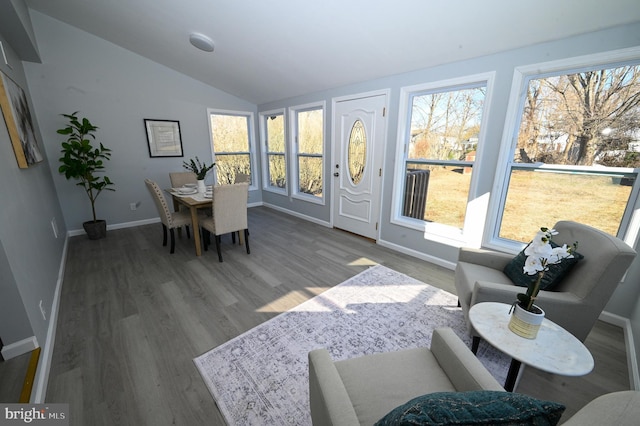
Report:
287,101,327,205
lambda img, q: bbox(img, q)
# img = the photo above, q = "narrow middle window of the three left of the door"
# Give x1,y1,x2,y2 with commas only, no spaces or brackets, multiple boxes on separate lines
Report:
260,111,287,193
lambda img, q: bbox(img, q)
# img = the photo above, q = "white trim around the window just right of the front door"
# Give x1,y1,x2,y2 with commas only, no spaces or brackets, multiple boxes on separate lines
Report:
390,71,496,247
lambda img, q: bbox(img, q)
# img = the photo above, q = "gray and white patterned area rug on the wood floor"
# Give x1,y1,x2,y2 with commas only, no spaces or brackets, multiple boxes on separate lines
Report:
194,265,510,426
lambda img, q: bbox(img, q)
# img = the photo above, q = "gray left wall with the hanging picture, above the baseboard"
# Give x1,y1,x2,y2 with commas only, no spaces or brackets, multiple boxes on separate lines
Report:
0,31,66,352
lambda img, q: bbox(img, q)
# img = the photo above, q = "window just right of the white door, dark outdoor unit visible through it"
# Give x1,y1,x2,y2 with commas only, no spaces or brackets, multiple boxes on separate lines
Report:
394,75,493,241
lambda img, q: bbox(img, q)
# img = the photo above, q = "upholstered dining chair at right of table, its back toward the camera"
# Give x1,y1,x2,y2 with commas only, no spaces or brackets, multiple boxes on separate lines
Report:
200,183,251,262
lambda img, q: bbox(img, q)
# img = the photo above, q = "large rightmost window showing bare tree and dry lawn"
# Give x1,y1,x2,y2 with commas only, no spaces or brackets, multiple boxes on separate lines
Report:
496,50,640,242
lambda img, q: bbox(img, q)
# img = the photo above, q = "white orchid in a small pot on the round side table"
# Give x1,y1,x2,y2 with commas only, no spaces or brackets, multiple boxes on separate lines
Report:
509,227,578,339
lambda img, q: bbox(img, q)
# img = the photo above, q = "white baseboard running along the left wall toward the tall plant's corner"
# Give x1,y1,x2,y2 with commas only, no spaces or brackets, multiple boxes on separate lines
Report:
30,231,69,404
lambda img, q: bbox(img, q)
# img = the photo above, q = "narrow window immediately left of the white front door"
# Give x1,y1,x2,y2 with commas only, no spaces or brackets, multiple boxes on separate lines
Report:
291,105,324,202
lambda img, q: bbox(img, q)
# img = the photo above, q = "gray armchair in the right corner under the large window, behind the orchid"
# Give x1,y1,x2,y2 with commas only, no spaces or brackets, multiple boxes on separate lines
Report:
455,221,636,342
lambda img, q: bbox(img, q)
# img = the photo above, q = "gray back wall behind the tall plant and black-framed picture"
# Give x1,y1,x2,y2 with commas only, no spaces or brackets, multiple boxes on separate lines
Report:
25,11,259,230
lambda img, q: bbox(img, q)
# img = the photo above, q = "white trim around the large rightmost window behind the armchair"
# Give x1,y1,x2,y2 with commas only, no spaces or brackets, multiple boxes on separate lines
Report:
483,47,640,253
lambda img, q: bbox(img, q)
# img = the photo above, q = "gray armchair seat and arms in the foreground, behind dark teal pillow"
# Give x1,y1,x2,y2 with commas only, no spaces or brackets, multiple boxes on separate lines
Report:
309,328,504,426
